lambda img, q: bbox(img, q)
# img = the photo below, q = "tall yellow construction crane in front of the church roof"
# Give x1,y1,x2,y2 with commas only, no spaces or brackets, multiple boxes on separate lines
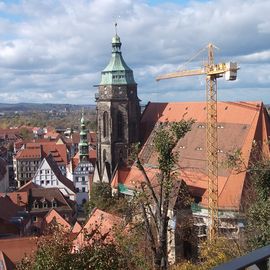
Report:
156,43,239,241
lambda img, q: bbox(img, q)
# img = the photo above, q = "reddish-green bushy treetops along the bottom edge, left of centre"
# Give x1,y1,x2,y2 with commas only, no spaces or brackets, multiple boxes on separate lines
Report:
17,225,143,270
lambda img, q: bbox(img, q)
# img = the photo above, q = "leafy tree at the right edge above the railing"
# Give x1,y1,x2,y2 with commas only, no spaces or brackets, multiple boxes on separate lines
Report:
225,142,270,251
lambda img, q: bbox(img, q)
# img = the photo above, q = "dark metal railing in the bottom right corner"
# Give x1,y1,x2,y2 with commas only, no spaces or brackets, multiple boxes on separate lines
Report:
213,245,270,270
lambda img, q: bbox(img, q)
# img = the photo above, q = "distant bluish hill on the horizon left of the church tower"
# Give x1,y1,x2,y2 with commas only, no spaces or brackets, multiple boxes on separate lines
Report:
0,103,96,112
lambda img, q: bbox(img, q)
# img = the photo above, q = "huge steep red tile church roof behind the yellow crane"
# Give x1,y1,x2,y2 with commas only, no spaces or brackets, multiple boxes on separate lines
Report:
118,102,270,210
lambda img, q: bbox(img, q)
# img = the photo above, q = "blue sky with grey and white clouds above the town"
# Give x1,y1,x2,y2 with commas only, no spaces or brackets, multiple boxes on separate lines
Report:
0,0,270,104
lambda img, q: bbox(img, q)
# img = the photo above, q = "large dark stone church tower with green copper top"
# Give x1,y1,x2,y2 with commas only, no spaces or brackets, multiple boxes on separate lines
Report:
96,28,140,181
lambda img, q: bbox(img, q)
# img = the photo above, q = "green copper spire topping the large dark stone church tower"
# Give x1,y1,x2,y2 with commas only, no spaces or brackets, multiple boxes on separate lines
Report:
100,24,136,85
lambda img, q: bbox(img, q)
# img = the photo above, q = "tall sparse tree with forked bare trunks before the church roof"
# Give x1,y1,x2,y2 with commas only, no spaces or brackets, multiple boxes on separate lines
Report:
131,120,194,269
